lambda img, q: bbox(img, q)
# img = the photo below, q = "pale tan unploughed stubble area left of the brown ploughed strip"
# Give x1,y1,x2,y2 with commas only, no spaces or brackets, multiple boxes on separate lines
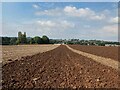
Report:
0,45,59,63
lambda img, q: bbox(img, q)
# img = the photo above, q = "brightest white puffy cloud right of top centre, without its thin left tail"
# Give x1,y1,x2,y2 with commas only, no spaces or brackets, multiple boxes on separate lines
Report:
64,6,105,20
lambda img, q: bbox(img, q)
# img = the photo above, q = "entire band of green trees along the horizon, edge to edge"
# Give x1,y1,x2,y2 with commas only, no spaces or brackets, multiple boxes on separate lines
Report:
0,32,120,46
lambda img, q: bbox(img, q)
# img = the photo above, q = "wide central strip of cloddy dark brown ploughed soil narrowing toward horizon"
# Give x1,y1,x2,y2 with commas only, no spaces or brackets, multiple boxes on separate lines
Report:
2,46,120,88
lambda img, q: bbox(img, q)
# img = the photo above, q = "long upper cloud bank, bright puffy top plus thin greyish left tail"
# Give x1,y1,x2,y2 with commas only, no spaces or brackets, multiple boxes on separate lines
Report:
35,6,105,20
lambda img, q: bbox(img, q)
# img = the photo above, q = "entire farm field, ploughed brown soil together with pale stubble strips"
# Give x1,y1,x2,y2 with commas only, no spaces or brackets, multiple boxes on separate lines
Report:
2,45,120,89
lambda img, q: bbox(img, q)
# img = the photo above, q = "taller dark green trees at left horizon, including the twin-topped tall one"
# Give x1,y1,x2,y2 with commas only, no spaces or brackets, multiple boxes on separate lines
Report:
2,32,50,45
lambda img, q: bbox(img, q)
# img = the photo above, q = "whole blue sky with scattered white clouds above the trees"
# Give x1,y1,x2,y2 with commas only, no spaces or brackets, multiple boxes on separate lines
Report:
2,2,118,41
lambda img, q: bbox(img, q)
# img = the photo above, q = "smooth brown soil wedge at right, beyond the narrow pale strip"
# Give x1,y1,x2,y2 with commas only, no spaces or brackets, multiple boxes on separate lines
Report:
69,45,120,61
